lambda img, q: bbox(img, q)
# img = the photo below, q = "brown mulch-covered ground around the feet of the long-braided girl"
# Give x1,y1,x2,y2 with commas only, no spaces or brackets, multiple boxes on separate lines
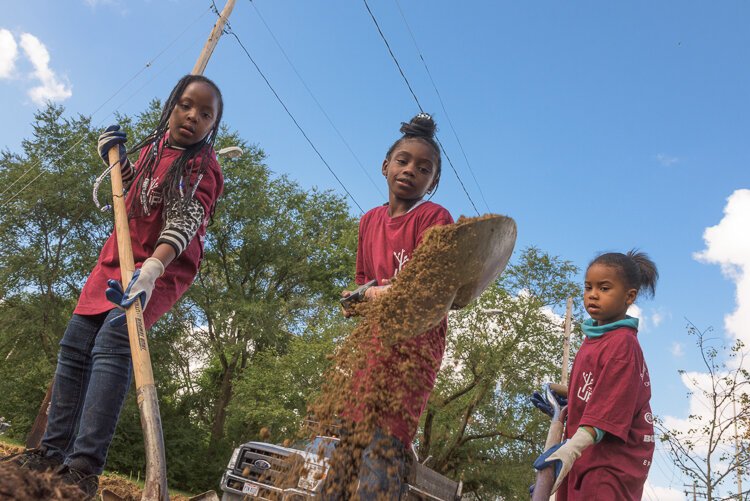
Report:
0,442,194,501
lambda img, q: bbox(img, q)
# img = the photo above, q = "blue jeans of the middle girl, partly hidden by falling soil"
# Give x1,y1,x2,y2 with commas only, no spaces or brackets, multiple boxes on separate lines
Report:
321,428,407,501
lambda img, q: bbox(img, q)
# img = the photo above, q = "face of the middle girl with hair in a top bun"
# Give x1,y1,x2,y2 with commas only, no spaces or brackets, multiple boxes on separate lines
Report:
383,139,438,200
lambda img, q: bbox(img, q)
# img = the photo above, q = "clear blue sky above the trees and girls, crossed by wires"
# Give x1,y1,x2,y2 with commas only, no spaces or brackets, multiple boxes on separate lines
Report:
0,0,750,499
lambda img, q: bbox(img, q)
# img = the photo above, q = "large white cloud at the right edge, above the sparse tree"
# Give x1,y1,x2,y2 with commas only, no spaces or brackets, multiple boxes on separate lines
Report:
693,189,750,346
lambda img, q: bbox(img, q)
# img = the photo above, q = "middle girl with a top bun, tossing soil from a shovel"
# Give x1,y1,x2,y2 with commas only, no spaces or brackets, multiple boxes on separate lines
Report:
323,113,453,500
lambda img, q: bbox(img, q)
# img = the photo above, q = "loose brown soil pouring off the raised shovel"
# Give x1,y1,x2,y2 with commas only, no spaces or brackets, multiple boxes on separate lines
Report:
302,215,484,499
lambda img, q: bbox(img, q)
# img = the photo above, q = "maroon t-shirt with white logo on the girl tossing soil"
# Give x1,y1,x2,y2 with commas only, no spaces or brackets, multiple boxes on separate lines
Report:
355,202,453,447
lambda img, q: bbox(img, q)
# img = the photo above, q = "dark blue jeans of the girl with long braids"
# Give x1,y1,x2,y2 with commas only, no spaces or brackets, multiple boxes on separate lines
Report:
42,308,132,475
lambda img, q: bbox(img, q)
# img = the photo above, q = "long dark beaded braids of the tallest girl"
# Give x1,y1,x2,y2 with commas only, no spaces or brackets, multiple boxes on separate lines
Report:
128,75,224,217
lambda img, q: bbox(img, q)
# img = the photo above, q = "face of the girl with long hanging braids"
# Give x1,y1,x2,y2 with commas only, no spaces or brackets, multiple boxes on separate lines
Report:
169,82,219,148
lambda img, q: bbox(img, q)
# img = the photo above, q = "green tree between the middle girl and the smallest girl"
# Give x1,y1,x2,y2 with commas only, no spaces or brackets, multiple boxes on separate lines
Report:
417,247,579,499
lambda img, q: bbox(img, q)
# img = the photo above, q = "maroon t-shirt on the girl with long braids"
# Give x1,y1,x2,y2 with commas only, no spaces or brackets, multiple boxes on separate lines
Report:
73,139,224,328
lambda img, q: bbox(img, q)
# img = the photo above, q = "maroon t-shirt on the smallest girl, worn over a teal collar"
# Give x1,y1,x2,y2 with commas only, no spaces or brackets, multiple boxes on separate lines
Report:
557,327,654,501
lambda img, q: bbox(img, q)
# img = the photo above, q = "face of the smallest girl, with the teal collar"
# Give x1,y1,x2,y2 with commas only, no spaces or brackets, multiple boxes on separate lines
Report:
583,263,638,325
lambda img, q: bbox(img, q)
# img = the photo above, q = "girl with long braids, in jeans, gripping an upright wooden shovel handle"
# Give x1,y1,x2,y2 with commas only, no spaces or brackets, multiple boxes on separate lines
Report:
5,75,223,497
